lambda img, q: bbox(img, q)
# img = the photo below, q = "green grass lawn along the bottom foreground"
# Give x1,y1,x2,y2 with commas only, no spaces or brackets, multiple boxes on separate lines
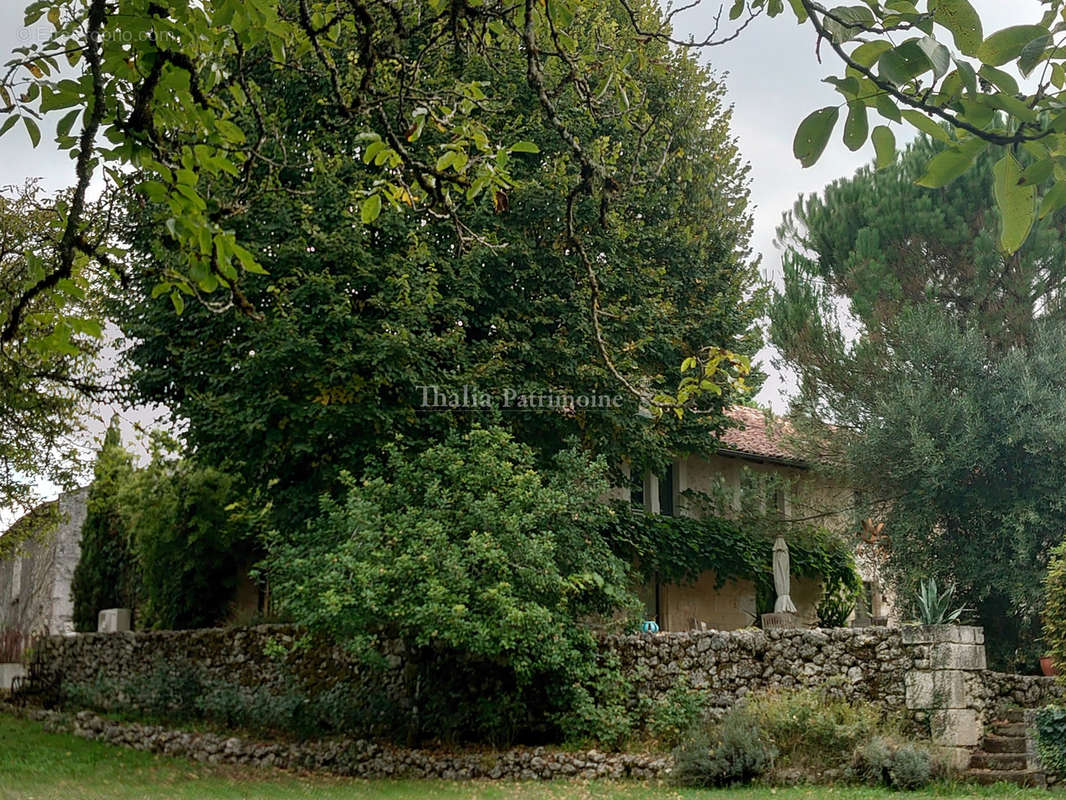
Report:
0,714,1049,800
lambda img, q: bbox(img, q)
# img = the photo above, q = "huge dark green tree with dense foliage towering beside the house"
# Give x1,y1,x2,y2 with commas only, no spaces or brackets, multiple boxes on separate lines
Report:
115,9,761,529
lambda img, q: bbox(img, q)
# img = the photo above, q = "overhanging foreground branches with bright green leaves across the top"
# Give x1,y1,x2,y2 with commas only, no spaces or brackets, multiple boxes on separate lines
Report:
0,0,1066,388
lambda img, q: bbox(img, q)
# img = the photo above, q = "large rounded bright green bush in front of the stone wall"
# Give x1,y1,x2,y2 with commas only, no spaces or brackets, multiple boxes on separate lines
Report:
268,429,636,742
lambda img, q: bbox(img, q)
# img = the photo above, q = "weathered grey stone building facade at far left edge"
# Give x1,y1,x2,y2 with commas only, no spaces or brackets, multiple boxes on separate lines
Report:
0,489,88,635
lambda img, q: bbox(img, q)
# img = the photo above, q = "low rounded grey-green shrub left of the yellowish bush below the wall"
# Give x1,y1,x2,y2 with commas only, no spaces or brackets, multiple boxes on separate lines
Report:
673,707,777,787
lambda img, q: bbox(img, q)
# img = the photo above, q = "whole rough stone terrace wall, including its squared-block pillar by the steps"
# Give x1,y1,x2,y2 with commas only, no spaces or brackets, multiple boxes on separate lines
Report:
20,625,1064,774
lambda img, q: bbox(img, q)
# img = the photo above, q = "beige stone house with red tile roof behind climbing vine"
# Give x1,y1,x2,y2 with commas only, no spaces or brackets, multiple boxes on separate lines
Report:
630,406,891,631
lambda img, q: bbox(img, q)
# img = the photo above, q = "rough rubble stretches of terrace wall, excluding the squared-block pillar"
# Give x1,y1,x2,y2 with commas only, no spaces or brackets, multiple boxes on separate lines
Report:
38,625,926,708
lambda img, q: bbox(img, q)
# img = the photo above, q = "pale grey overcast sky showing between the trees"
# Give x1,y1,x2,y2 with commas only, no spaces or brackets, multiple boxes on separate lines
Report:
0,0,1040,507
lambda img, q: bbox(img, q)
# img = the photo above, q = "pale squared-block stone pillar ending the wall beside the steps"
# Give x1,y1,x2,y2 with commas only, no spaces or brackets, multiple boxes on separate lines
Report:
902,625,986,769
